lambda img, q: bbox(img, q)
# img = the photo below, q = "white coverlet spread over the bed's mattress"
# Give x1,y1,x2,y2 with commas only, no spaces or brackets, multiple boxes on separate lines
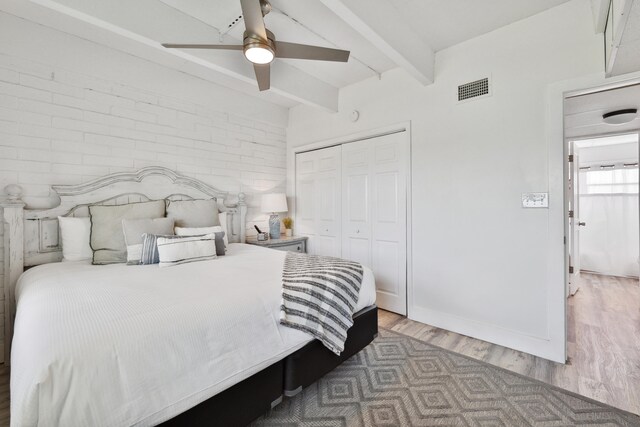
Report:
11,244,375,427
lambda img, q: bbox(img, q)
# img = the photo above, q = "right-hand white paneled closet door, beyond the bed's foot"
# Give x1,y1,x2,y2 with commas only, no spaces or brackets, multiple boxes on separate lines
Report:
342,133,409,315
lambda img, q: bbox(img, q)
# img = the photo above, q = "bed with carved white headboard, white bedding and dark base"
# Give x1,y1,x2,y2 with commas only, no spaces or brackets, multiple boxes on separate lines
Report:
3,168,377,426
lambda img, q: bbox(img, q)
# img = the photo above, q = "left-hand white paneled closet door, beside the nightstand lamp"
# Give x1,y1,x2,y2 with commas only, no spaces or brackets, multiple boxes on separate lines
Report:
294,146,342,257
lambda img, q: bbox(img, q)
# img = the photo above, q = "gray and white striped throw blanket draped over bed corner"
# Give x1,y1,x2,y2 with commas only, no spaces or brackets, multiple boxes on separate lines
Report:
280,252,363,355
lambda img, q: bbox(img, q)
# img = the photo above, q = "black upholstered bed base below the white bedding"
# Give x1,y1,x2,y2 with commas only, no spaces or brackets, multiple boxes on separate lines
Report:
161,305,378,427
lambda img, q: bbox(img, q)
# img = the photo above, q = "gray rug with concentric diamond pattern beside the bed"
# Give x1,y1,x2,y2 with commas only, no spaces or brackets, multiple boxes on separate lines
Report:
253,328,640,427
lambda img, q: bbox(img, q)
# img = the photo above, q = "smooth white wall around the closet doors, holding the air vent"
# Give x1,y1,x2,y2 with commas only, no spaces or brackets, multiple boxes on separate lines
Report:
287,0,603,360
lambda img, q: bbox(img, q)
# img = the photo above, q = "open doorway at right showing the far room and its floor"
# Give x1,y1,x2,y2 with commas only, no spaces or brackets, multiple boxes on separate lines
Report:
564,84,640,402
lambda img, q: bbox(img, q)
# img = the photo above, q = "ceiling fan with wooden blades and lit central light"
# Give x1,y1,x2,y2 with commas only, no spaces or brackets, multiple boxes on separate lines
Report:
162,0,350,91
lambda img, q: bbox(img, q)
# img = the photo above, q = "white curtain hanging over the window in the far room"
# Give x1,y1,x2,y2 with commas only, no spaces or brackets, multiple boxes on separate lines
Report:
579,168,640,277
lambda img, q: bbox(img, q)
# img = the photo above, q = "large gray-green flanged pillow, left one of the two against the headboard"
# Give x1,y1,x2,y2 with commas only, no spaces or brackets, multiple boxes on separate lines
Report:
89,200,165,265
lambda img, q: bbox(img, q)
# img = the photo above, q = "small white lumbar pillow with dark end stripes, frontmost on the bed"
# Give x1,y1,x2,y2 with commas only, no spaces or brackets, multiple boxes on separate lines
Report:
157,234,217,267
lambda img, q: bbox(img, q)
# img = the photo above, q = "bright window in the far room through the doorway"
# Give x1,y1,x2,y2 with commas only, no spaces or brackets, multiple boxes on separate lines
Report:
580,168,639,194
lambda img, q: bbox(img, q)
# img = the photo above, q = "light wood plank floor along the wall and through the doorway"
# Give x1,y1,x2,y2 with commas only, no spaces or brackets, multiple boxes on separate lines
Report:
0,274,640,426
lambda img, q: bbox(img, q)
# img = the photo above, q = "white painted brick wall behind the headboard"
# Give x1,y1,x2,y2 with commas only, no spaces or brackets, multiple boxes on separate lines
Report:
0,13,288,362
